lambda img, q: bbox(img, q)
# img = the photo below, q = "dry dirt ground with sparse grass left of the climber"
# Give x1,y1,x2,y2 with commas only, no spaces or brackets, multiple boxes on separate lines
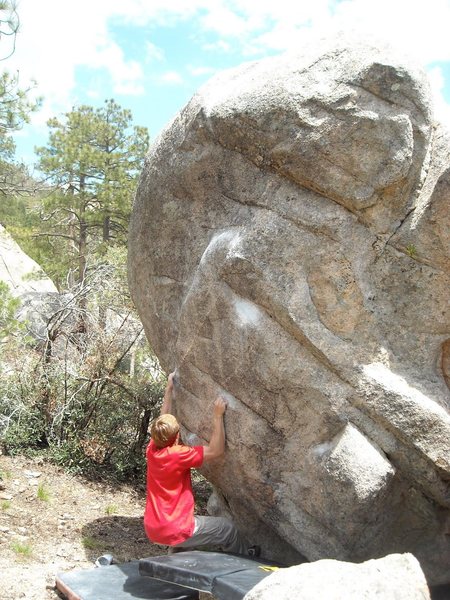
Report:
0,455,209,600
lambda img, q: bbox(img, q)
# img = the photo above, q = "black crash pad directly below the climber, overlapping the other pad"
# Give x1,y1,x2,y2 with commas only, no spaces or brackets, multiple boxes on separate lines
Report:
139,550,273,600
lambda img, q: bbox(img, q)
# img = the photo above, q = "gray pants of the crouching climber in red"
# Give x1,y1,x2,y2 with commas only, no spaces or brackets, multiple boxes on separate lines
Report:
169,516,247,555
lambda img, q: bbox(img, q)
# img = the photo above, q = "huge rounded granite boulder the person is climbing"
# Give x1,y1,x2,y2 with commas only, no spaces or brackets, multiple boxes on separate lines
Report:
129,39,450,583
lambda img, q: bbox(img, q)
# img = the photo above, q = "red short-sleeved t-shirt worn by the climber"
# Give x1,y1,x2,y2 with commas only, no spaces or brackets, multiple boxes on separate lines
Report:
144,440,203,546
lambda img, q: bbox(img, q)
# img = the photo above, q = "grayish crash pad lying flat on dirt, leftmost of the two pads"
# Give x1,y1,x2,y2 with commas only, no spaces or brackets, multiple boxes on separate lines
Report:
56,560,199,600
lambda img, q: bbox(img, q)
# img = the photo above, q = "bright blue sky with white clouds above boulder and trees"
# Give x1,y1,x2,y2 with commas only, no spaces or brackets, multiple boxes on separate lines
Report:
4,0,450,166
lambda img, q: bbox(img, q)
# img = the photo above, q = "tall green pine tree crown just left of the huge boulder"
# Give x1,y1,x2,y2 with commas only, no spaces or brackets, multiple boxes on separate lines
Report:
37,100,148,283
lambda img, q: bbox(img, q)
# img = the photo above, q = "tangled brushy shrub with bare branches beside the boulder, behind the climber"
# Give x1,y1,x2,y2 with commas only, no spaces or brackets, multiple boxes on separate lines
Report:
0,249,164,480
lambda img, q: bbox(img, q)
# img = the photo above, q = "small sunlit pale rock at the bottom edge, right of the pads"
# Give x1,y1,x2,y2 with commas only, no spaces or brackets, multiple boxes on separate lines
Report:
244,554,430,600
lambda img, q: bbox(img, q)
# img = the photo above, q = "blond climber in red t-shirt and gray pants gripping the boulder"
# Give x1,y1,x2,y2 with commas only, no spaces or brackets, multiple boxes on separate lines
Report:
144,373,251,555
